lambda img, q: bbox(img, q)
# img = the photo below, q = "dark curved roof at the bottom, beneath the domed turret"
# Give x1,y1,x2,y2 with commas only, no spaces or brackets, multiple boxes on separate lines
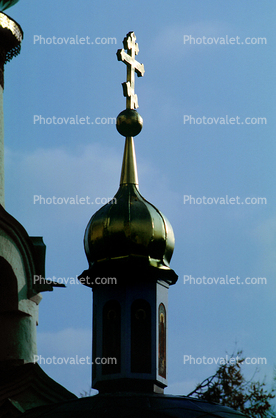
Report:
23,393,249,418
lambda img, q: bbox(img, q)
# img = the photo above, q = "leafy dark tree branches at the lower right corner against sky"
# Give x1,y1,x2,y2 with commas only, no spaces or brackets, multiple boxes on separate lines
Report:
188,350,276,418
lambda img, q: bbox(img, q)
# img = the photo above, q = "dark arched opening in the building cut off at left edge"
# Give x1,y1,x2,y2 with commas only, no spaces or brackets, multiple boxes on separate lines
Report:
0,257,18,312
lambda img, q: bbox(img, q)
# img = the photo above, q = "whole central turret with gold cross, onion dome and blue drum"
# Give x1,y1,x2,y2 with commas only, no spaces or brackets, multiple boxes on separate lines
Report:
81,32,177,393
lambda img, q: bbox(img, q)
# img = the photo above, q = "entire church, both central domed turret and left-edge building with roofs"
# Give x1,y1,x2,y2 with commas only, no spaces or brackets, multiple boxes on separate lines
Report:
0,0,249,418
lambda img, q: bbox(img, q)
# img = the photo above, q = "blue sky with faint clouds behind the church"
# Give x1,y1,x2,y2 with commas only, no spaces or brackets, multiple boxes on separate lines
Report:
4,0,276,395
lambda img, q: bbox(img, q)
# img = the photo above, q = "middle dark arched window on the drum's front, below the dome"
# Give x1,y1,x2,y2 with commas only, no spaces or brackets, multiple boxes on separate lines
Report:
131,299,151,373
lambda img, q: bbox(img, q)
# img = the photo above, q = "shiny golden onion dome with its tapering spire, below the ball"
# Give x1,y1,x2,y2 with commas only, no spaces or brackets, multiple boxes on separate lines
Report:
84,132,177,283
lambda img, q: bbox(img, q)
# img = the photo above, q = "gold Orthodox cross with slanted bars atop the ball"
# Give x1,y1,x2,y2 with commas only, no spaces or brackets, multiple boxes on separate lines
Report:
117,32,145,109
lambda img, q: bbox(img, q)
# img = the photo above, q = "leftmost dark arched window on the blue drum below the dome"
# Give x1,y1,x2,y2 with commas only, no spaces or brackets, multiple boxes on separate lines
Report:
102,300,121,374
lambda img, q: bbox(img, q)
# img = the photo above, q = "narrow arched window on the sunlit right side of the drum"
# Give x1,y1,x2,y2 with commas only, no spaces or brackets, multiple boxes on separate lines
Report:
158,303,167,379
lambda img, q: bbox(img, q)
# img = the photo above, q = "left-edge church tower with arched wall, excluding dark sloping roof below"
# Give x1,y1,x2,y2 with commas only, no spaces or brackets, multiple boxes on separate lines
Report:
0,0,43,367
